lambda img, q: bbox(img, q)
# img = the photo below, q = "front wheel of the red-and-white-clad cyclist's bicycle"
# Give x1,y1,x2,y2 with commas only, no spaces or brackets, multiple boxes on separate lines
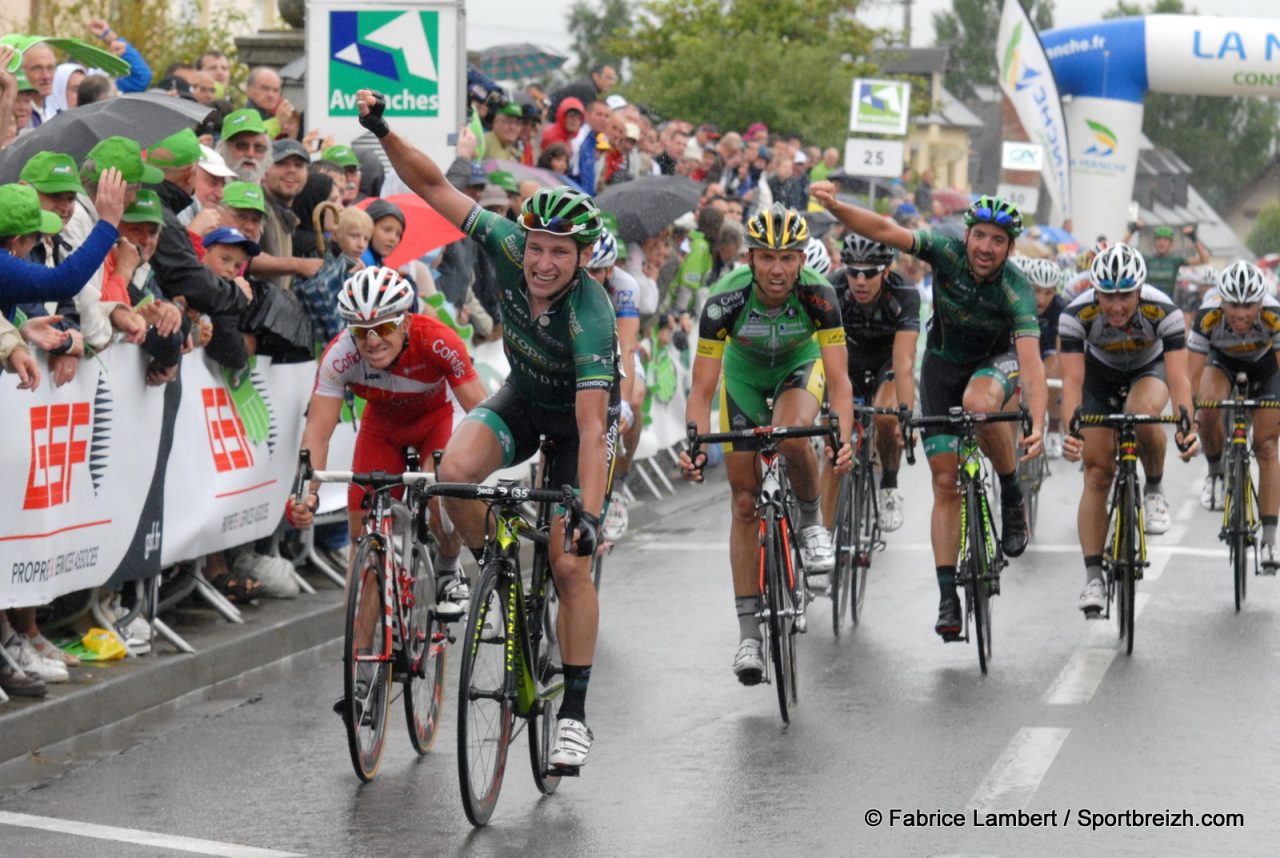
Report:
342,537,392,781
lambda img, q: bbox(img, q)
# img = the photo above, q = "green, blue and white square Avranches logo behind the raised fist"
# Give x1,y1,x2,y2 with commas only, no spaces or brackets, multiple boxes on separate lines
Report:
329,12,440,117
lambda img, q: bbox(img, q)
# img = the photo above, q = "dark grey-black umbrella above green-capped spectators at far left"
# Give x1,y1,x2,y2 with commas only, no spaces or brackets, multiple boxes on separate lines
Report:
0,92,214,183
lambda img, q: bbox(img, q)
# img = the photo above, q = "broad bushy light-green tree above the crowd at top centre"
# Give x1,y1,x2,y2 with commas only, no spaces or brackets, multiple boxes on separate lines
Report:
608,0,876,146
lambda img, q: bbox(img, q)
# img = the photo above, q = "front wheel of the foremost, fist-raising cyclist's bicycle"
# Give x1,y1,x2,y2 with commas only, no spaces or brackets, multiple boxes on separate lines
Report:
458,561,516,826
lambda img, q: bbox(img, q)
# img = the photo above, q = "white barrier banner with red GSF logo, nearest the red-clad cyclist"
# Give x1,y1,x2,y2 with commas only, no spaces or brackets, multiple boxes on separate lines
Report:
163,356,316,565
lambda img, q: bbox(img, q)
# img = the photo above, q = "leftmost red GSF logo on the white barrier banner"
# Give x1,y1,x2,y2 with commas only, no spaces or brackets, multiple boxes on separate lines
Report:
22,402,93,510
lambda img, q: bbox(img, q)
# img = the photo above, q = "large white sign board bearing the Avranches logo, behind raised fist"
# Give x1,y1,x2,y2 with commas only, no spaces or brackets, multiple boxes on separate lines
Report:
306,0,466,172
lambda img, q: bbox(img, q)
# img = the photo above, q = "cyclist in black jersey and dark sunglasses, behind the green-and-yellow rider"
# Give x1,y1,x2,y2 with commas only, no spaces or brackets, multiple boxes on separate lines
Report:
822,233,920,531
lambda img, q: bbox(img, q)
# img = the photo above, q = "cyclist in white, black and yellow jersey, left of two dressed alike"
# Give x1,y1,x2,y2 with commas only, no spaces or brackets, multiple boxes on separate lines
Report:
1059,245,1199,619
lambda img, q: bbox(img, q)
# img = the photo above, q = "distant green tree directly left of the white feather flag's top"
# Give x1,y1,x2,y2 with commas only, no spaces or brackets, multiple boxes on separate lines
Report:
933,0,1053,99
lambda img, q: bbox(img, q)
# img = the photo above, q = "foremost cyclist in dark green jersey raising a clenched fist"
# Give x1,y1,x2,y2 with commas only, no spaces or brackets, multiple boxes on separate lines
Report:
356,90,618,771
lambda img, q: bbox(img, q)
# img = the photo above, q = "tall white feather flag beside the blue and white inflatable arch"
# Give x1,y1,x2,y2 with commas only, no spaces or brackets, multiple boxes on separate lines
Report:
996,0,1075,227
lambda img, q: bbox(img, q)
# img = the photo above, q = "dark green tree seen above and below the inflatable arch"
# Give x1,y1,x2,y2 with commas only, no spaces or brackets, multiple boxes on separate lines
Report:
1103,0,1280,209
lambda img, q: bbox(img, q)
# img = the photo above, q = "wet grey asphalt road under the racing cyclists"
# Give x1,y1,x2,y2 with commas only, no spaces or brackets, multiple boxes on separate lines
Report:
0,453,1280,858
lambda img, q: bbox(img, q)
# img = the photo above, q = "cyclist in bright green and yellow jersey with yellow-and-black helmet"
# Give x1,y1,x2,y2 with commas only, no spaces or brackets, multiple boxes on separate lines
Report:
680,204,854,685
